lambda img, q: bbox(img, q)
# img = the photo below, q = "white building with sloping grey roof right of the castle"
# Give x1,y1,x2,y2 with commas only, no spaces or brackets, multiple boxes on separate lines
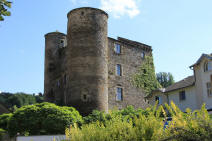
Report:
146,54,212,111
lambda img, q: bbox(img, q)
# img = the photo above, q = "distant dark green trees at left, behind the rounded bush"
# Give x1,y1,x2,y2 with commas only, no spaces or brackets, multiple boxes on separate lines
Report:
0,93,43,111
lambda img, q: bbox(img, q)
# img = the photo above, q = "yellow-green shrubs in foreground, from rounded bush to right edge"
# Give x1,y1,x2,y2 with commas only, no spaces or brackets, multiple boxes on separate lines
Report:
66,102,212,141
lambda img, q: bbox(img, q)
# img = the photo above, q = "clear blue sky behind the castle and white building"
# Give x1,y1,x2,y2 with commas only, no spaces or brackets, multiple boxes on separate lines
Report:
0,0,212,93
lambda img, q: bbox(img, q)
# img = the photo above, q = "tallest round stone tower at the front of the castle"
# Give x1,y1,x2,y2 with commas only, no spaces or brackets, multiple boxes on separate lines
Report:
65,7,108,115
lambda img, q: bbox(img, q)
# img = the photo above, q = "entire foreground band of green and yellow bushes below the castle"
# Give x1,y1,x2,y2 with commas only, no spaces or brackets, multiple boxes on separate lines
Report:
0,102,212,141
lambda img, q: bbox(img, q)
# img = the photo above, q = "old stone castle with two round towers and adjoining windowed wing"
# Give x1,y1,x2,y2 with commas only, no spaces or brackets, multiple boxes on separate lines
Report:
44,7,152,115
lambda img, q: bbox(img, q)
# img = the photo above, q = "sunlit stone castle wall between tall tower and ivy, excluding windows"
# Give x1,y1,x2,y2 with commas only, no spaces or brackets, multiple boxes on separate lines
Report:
108,38,152,109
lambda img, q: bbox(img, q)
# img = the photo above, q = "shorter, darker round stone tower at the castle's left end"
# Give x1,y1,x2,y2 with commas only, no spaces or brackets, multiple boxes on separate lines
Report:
44,32,66,102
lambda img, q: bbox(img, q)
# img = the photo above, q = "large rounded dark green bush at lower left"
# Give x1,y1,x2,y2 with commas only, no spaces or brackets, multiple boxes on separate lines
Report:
8,103,82,136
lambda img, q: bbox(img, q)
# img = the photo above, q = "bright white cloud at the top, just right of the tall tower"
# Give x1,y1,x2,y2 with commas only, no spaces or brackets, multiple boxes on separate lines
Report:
100,0,140,18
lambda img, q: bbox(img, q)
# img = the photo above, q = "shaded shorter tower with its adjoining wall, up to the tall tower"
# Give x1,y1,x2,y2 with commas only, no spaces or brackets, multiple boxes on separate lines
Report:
44,32,66,105
